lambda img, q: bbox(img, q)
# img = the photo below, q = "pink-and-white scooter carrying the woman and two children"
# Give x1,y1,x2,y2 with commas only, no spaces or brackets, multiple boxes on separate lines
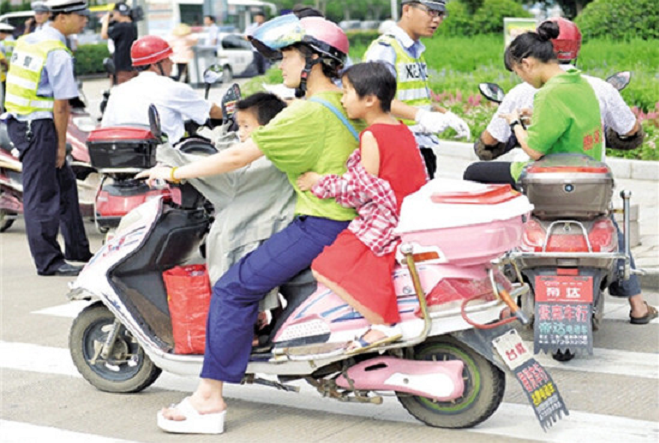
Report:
68,106,568,428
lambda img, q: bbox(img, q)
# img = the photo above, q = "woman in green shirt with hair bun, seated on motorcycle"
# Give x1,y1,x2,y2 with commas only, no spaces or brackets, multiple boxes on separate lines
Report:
464,21,603,186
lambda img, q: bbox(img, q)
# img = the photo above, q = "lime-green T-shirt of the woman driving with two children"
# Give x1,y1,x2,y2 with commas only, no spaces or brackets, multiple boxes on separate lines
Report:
252,92,366,221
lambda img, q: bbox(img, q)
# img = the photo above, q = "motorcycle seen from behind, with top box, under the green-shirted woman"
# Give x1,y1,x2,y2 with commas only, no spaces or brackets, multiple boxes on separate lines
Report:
479,72,636,361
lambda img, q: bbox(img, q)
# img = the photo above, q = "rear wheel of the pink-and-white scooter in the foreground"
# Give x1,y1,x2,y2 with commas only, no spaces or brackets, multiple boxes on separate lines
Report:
396,336,506,429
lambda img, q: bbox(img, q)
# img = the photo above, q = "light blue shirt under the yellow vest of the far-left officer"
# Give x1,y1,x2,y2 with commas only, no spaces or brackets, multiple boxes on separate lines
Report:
7,26,79,121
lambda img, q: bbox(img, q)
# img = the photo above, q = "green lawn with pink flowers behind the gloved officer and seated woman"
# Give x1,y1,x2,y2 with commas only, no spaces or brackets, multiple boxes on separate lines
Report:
244,35,659,160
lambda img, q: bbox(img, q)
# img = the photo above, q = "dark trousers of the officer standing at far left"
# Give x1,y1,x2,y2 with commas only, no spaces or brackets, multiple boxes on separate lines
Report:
7,118,92,275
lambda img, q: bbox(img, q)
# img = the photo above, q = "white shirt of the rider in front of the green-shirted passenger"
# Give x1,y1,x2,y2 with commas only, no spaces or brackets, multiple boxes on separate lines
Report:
487,64,636,161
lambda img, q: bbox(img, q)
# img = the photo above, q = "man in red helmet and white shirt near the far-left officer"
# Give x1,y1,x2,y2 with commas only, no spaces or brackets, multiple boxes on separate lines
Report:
101,35,222,144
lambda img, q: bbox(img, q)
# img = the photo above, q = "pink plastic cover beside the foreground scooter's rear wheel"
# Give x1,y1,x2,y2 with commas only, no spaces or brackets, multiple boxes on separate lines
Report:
336,357,464,401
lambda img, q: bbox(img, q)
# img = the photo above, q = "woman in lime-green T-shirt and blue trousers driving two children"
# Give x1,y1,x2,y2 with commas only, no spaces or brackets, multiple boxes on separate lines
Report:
140,15,363,433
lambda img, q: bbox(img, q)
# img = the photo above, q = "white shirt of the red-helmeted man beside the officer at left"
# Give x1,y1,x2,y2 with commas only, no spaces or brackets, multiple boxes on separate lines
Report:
101,71,211,143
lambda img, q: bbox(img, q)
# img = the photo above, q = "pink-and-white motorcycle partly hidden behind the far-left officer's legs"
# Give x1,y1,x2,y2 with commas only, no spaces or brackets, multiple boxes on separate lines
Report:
0,83,99,232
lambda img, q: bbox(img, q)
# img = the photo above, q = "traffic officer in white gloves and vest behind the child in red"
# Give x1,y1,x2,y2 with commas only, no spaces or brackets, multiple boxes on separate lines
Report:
364,0,471,178
